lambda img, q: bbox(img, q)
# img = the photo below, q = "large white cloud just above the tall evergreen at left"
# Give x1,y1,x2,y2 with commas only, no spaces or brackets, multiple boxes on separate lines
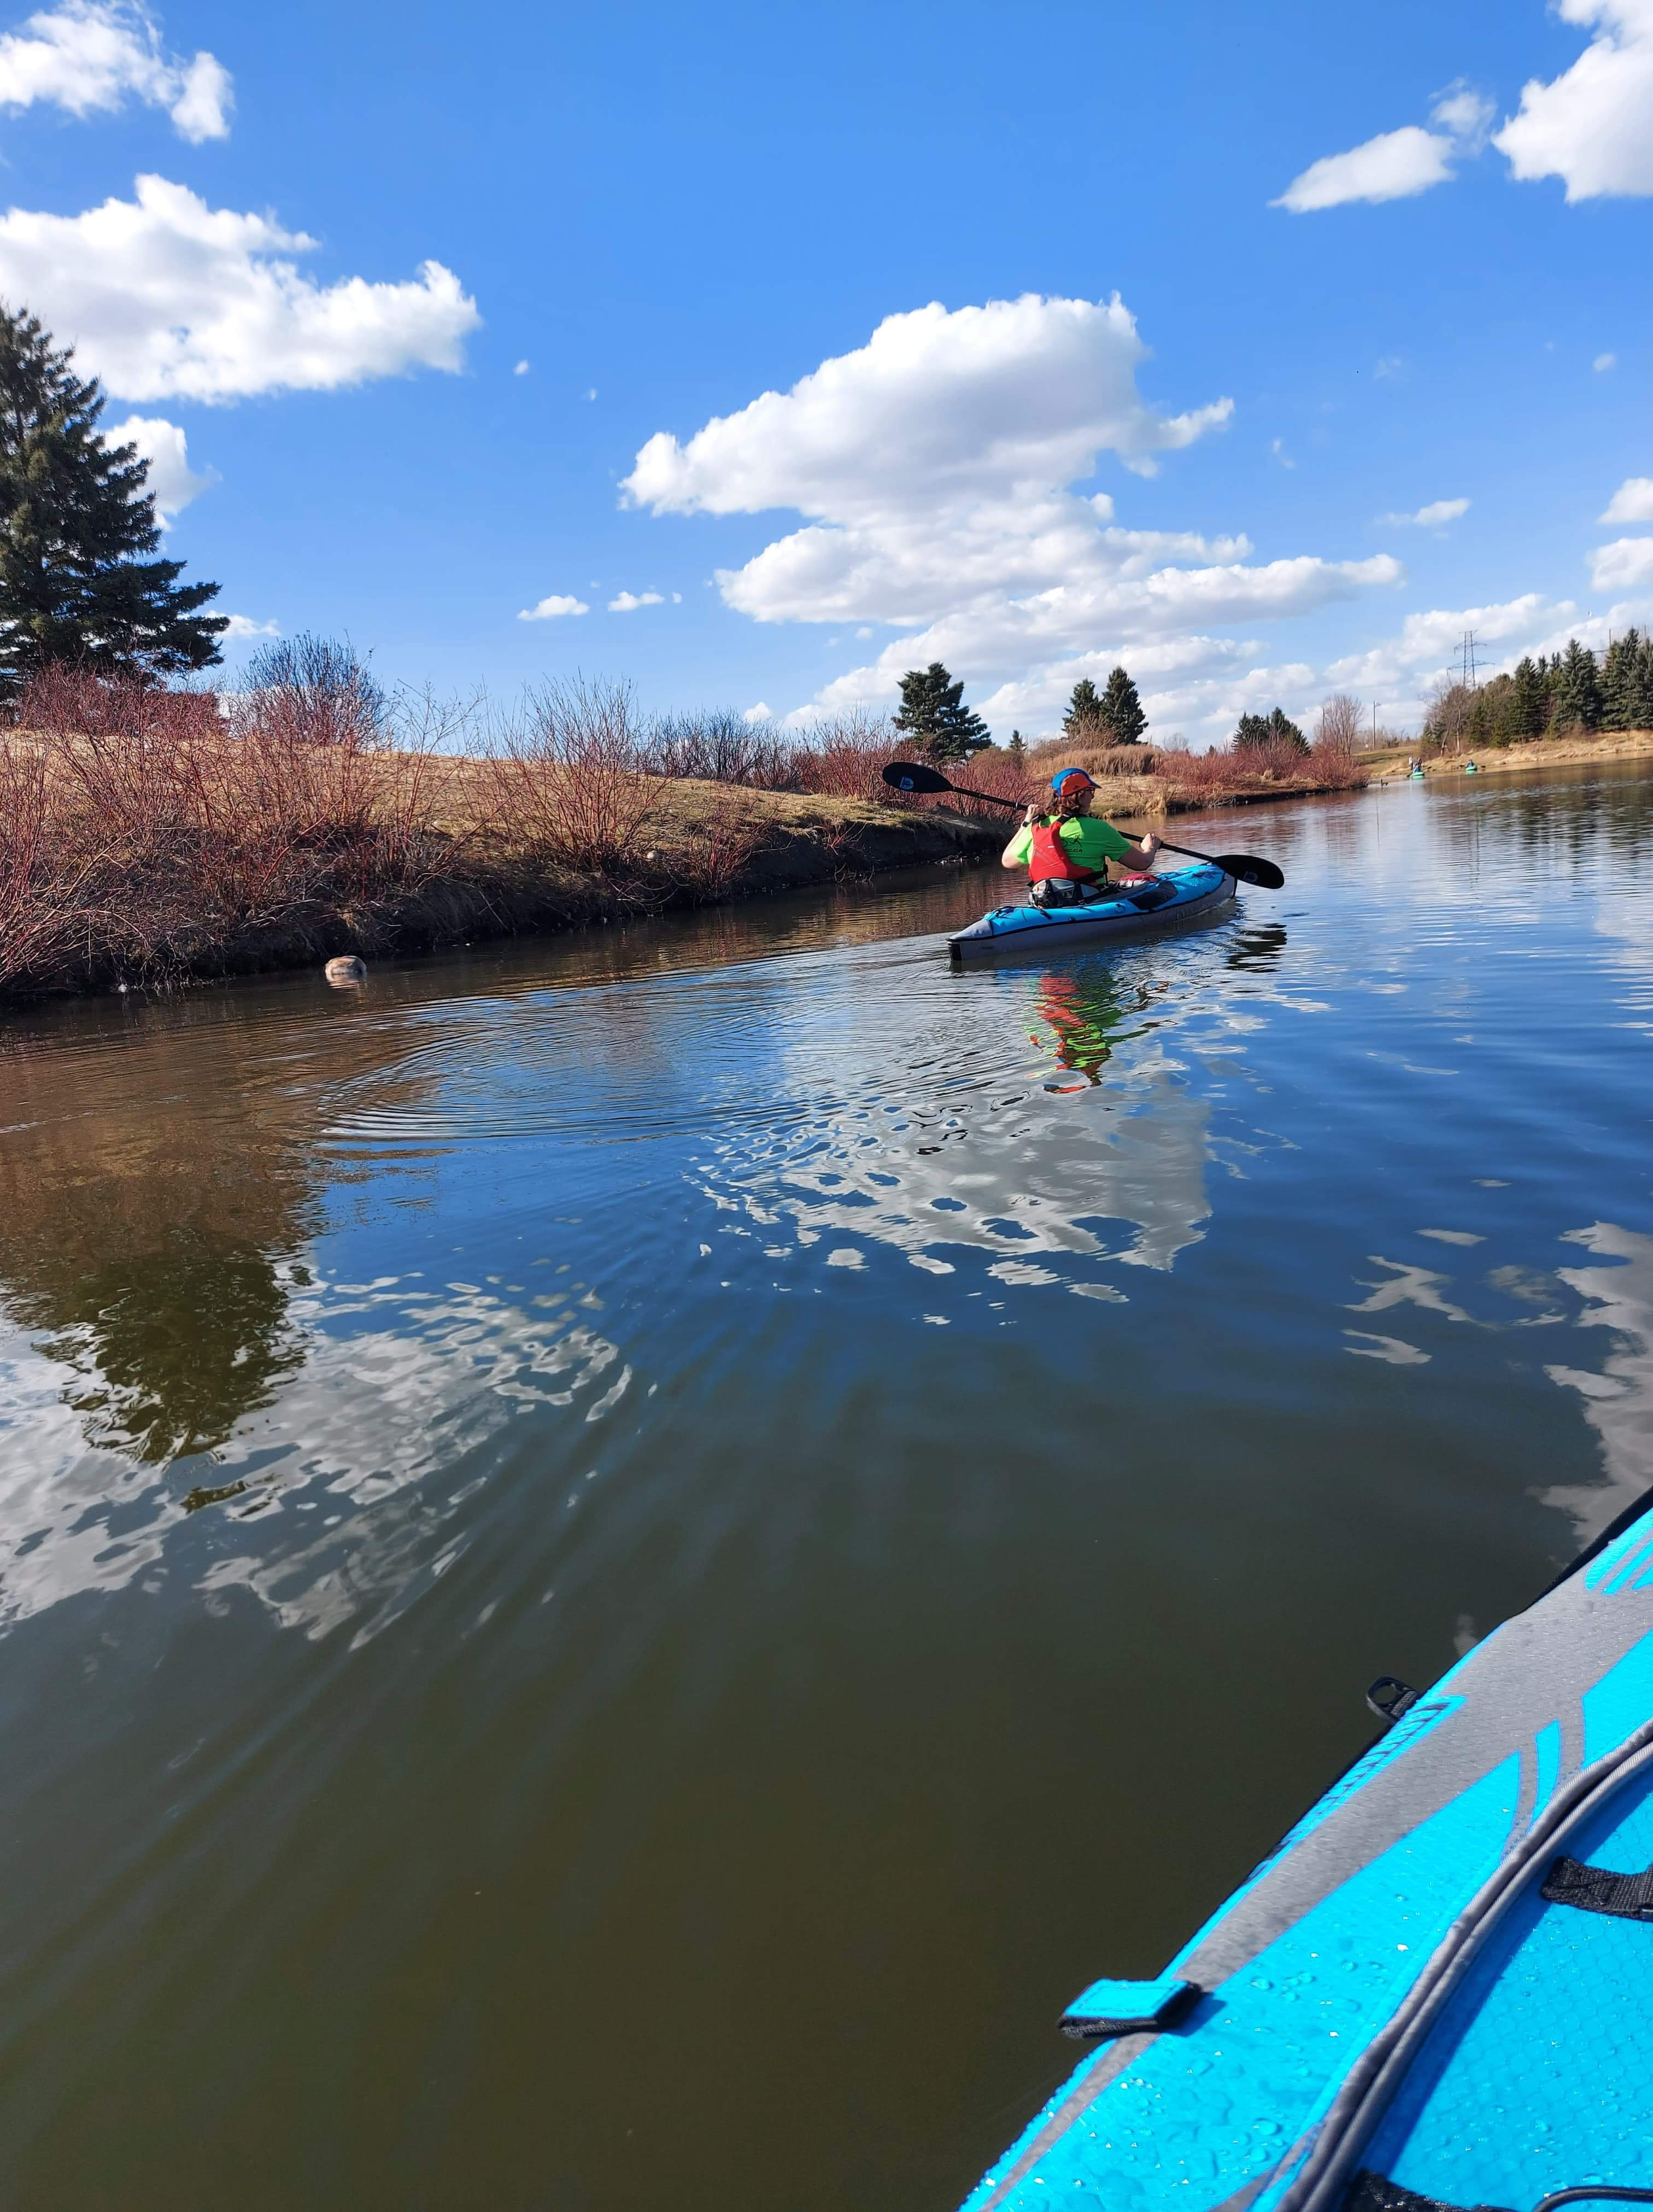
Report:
0,177,480,400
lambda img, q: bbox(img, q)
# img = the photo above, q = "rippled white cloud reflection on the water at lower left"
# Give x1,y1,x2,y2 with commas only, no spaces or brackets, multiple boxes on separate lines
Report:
0,1281,631,1635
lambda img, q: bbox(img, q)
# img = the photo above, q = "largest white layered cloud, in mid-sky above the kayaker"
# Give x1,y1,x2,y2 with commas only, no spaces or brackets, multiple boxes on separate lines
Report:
624,294,1403,739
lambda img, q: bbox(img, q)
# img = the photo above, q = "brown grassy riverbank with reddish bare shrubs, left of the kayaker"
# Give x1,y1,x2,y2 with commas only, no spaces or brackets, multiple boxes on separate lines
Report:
0,732,1005,1002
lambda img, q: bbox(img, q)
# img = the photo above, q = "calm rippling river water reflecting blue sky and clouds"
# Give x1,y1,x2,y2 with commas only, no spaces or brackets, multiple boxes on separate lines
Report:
0,772,1653,2212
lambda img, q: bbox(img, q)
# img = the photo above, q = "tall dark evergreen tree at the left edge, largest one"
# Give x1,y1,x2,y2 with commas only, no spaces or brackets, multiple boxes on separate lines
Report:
0,307,228,697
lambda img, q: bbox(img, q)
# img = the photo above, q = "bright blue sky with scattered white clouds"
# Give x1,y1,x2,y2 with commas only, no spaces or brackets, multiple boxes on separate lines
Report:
13,0,1653,746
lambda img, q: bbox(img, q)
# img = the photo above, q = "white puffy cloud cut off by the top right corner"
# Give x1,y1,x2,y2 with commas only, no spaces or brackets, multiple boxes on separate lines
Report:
1494,0,1653,199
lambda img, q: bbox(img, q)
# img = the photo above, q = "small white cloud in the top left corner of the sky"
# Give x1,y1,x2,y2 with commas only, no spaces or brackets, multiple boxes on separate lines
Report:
0,0,235,146
